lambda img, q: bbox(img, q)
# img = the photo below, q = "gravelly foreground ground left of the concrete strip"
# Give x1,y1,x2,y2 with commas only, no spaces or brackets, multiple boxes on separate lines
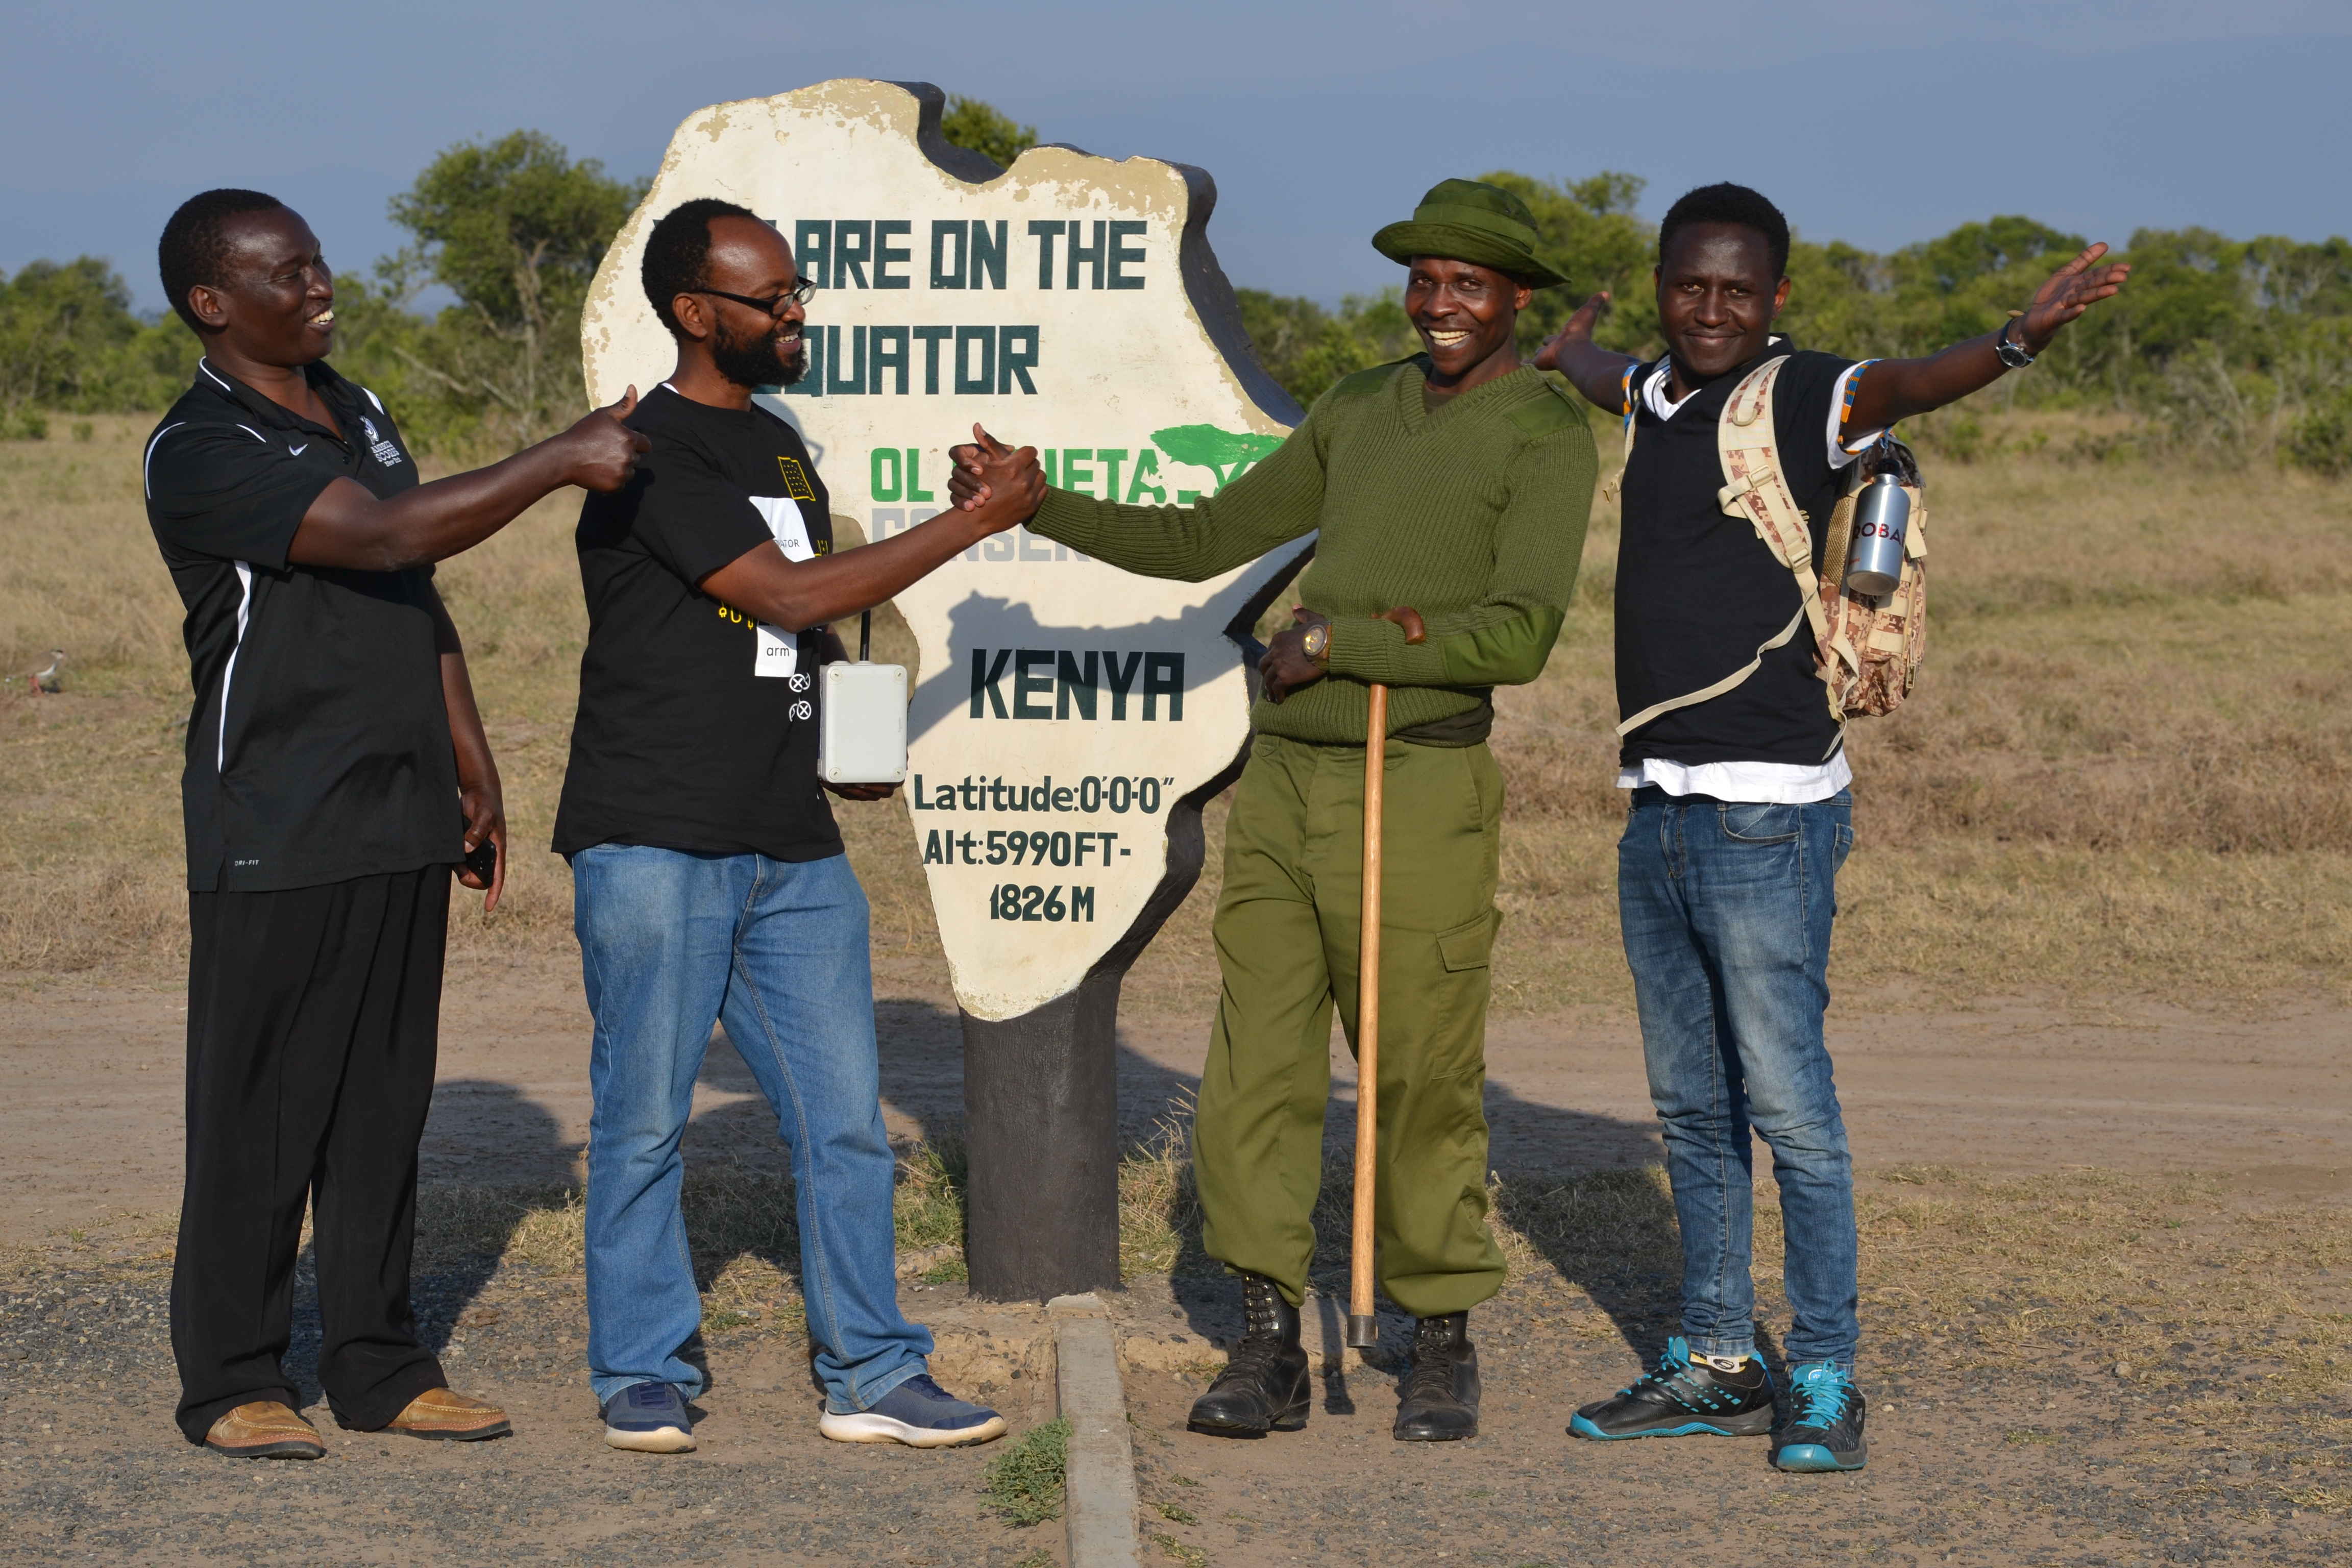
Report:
0,1262,1061,1568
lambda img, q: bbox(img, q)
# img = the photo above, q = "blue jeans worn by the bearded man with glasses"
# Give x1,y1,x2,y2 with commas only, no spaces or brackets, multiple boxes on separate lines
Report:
572,844,932,1413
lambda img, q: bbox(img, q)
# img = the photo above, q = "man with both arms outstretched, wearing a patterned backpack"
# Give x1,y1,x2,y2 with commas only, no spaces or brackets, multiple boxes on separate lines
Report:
1536,186,2126,1472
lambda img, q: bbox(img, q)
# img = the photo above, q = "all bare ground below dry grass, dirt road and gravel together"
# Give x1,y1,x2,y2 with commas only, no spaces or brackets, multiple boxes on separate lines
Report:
0,962,2352,1568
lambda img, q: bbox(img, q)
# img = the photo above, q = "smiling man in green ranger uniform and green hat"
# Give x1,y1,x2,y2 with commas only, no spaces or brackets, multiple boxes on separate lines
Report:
952,179,1595,1441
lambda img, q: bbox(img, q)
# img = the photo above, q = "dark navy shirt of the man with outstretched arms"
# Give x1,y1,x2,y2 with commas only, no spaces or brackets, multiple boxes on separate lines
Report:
1616,338,1853,766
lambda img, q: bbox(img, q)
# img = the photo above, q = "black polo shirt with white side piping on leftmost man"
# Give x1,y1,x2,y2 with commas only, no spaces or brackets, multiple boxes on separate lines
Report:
146,360,465,893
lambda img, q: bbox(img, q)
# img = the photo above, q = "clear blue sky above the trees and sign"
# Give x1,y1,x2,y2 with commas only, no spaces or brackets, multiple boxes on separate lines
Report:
0,0,2352,308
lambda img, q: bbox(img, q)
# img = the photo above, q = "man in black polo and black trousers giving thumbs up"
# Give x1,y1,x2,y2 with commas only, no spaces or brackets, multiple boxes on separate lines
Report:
143,190,645,1460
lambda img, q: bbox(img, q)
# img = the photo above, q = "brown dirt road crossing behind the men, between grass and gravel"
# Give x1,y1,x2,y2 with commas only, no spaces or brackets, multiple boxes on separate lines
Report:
0,959,2352,1243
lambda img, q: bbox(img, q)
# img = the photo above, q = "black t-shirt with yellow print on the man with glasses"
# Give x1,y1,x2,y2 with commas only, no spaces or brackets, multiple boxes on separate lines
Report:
555,385,842,861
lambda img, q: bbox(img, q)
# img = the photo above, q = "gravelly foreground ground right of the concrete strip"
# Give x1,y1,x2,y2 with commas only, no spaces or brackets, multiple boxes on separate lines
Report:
1126,1279,2352,1568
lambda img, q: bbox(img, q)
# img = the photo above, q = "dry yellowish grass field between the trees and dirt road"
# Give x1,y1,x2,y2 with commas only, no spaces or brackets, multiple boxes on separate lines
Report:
0,419,2352,1011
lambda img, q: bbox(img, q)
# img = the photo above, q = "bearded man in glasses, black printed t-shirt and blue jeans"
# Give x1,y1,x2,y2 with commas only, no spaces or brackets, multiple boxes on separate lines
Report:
555,200,1042,1453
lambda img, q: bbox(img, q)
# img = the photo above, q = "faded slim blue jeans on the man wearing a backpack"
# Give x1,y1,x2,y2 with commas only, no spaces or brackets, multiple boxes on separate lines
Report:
1618,788,1860,1373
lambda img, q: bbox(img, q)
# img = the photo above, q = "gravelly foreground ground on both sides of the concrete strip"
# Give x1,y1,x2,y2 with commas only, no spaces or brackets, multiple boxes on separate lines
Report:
0,1194,2352,1568
